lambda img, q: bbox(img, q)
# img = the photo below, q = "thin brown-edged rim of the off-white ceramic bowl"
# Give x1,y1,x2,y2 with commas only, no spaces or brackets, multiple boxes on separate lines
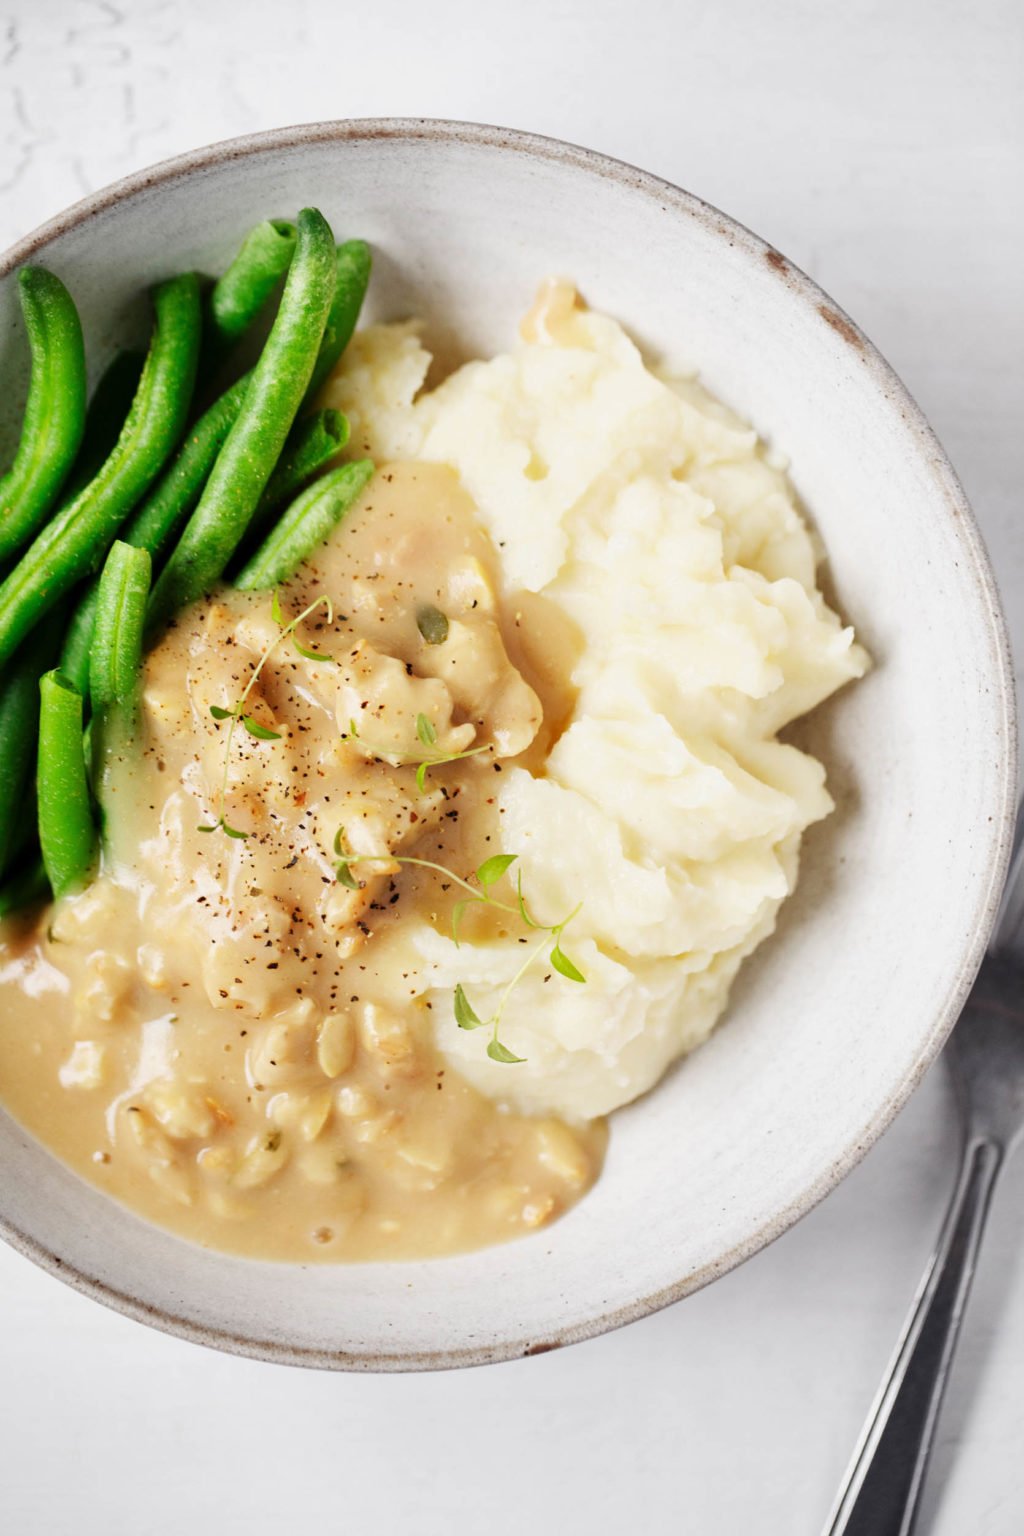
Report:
0,117,1018,1372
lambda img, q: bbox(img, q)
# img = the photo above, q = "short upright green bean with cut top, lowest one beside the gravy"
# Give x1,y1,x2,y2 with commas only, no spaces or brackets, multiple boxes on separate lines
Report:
35,671,97,897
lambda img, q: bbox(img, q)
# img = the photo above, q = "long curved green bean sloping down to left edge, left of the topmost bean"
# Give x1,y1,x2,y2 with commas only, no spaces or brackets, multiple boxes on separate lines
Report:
0,273,200,667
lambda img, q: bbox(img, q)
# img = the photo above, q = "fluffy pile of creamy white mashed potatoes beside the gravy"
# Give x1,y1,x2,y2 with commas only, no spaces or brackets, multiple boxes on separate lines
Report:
327,284,866,1120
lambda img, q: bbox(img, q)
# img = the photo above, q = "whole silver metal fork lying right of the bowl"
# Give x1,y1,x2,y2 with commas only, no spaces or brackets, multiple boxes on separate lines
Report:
826,802,1024,1536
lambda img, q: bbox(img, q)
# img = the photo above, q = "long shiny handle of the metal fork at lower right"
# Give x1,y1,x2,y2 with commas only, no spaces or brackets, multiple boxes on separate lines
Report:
826,1135,1004,1536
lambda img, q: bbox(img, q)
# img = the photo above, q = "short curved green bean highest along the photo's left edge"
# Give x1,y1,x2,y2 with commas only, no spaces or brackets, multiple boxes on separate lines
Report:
0,267,86,561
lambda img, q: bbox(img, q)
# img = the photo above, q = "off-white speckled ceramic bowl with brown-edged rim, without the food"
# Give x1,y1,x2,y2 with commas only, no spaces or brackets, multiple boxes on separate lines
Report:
0,120,1016,1370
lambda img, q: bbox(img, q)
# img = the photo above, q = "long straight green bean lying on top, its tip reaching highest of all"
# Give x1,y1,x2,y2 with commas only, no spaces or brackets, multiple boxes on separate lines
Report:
150,209,335,633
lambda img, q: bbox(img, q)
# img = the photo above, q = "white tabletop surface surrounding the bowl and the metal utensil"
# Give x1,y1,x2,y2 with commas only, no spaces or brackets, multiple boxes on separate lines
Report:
0,0,1024,1536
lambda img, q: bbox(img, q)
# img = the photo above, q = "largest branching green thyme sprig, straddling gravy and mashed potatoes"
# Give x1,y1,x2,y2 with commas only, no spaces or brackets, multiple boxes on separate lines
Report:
335,828,586,1064
